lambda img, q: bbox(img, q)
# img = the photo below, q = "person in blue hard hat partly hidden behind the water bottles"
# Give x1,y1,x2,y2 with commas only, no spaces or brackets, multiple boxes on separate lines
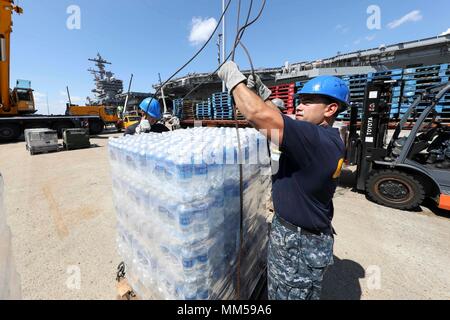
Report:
125,98,170,135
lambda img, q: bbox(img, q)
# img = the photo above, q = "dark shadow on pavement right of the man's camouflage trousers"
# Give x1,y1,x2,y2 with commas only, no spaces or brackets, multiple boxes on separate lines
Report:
322,256,366,300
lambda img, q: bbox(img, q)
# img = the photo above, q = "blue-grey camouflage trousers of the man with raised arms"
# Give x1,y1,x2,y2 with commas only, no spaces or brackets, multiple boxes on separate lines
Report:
267,216,334,300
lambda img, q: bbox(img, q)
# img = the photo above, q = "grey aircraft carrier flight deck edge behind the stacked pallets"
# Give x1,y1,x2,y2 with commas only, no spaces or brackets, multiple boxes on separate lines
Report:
153,34,450,100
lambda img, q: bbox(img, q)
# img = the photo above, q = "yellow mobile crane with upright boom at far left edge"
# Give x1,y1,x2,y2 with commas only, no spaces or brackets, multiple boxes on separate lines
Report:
0,0,100,142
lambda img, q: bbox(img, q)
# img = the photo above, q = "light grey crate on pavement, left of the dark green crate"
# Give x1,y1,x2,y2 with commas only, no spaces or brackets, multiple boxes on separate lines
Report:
25,129,59,155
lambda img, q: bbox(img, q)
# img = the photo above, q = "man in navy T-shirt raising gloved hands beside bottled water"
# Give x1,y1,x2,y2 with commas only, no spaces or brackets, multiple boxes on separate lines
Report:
219,62,350,300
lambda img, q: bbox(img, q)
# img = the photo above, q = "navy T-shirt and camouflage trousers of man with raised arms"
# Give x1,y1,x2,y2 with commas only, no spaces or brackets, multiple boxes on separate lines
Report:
268,116,345,300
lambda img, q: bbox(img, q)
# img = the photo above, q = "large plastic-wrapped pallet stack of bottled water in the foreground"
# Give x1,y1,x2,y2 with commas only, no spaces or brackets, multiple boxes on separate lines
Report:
109,128,271,300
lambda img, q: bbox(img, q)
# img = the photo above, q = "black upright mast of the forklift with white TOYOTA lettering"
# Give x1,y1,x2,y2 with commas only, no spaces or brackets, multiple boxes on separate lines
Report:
356,81,392,191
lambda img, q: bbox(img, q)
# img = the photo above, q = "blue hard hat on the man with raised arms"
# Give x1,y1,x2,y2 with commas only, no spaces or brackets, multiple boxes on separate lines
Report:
299,76,350,107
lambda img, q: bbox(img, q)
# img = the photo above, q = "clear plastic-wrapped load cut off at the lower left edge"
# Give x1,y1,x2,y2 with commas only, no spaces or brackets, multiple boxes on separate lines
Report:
0,173,21,300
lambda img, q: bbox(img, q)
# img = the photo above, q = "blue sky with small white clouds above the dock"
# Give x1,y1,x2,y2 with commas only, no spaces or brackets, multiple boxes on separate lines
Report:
11,0,450,114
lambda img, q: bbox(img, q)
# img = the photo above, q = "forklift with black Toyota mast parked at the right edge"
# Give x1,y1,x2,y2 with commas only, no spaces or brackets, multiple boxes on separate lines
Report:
347,81,450,210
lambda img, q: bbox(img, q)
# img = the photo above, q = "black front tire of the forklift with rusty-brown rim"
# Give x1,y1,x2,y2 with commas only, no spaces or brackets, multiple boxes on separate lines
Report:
366,170,425,210
